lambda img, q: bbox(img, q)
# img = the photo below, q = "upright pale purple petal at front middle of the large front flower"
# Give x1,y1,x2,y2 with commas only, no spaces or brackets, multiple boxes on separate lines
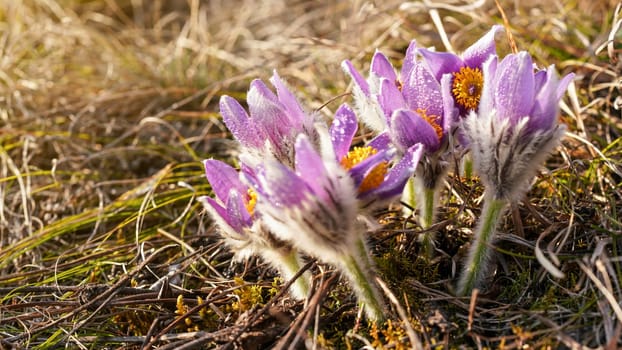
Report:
295,134,328,201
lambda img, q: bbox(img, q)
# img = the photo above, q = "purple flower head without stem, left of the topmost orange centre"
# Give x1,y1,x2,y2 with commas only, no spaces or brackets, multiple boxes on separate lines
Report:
342,41,455,157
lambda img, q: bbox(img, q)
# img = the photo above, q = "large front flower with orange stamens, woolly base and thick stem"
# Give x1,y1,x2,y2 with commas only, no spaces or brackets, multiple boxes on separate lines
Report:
245,105,421,319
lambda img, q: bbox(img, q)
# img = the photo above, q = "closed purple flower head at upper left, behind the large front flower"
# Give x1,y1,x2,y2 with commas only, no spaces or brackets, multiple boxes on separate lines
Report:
220,71,314,165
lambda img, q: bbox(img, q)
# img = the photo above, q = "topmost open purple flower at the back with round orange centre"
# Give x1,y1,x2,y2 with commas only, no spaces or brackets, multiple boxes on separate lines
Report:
417,25,503,116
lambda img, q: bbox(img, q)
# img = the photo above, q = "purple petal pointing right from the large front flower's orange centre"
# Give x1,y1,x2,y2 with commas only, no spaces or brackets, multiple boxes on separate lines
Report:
369,144,423,199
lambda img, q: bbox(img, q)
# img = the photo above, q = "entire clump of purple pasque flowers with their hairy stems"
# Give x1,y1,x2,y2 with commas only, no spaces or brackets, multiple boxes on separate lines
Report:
201,26,572,326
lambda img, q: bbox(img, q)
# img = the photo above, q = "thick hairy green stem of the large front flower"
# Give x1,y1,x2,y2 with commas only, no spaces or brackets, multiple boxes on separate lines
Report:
340,240,384,321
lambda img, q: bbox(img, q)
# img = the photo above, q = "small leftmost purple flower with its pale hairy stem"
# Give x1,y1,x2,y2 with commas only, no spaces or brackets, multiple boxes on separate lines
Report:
199,159,309,299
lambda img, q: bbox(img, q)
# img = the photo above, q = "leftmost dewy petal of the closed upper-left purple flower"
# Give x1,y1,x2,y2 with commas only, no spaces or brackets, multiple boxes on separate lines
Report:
220,95,265,148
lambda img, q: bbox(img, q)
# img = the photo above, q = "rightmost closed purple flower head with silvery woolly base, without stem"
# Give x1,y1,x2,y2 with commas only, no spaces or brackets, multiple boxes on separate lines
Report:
462,51,574,201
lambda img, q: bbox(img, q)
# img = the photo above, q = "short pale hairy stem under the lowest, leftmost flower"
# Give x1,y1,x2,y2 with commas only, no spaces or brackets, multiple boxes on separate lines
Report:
264,249,311,300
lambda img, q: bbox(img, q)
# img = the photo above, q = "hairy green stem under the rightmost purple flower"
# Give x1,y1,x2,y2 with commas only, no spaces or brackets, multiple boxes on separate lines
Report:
458,194,509,296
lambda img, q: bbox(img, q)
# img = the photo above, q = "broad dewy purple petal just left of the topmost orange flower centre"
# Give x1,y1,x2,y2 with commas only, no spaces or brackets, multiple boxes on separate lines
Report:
402,61,443,116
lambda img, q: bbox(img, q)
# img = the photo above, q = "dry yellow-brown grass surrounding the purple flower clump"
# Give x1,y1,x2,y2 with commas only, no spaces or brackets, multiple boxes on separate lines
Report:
0,0,622,349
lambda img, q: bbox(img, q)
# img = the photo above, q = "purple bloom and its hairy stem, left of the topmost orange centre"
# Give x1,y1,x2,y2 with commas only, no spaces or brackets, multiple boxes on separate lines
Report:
342,41,458,255
